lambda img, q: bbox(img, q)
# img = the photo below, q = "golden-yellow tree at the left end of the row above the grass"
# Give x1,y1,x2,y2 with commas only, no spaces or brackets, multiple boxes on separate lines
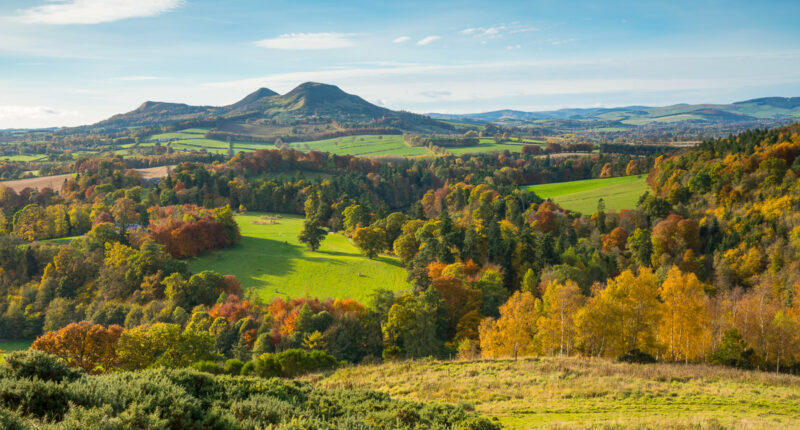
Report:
478,291,542,359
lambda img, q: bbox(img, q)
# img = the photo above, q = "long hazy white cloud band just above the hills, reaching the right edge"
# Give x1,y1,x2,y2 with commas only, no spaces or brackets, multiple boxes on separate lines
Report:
201,55,800,112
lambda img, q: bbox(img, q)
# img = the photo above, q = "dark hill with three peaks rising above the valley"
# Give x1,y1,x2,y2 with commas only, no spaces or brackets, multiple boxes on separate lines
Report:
90,82,452,135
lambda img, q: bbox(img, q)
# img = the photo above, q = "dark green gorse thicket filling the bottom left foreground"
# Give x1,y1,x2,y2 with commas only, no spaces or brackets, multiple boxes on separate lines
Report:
0,353,498,430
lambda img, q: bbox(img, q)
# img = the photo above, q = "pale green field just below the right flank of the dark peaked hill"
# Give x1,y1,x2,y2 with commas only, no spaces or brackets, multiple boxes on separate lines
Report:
289,134,430,157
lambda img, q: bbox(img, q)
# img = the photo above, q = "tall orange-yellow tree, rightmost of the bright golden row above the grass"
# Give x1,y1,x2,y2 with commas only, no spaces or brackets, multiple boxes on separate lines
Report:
658,266,710,363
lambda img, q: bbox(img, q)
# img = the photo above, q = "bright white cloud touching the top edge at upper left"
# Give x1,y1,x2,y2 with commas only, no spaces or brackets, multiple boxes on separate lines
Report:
18,0,183,25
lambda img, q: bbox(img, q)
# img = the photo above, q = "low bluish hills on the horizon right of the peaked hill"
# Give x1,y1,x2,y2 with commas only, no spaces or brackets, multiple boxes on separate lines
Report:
428,97,800,126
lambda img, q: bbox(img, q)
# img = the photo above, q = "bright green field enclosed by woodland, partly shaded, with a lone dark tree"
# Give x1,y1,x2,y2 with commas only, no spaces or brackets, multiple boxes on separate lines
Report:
189,213,409,302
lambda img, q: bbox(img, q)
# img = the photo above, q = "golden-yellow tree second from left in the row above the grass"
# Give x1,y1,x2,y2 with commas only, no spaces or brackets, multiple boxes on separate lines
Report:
536,281,585,356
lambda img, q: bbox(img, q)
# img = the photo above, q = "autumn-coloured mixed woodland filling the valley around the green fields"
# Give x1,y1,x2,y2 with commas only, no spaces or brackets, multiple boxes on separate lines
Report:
0,119,800,428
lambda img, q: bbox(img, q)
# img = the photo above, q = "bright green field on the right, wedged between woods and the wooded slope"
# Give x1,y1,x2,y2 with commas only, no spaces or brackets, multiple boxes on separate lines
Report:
525,175,648,214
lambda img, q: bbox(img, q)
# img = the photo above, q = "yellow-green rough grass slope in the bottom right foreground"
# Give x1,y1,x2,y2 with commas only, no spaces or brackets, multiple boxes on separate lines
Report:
306,358,800,429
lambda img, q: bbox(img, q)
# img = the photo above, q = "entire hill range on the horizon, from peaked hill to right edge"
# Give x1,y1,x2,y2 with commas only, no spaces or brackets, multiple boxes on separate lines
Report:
76,82,800,142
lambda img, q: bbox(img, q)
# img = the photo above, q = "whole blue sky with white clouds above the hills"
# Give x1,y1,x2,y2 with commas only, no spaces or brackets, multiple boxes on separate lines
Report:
0,0,800,129
